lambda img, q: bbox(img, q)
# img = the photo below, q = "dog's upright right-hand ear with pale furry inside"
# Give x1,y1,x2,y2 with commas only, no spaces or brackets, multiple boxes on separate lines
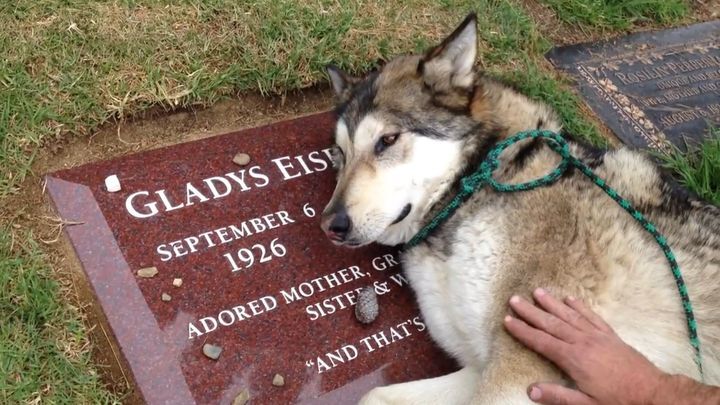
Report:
418,13,477,91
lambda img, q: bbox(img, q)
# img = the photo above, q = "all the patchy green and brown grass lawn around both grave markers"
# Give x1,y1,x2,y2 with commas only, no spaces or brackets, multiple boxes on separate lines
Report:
0,0,708,403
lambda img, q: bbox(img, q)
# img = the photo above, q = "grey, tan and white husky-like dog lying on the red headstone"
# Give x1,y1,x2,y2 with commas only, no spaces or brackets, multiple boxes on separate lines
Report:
321,14,720,404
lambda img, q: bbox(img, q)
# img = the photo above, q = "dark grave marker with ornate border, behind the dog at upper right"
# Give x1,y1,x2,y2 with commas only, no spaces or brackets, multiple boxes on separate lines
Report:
547,21,720,150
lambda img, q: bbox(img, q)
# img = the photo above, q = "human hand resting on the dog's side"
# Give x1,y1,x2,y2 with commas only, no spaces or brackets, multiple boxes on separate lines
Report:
504,289,669,405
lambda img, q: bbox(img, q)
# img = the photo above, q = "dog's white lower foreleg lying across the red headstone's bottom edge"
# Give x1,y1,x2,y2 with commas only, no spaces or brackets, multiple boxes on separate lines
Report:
360,367,479,405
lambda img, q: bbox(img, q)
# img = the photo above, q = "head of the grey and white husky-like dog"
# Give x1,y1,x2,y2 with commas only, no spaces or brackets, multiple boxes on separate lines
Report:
322,14,484,246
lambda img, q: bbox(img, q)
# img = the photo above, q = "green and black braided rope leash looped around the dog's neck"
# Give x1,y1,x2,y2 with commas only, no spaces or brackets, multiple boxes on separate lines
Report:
404,130,703,377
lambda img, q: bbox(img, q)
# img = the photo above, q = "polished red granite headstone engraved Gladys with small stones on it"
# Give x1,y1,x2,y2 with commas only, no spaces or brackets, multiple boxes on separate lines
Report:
47,113,454,404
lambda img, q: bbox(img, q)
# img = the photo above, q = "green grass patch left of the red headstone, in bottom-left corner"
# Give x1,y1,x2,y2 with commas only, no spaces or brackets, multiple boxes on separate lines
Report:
0,232,119,404
